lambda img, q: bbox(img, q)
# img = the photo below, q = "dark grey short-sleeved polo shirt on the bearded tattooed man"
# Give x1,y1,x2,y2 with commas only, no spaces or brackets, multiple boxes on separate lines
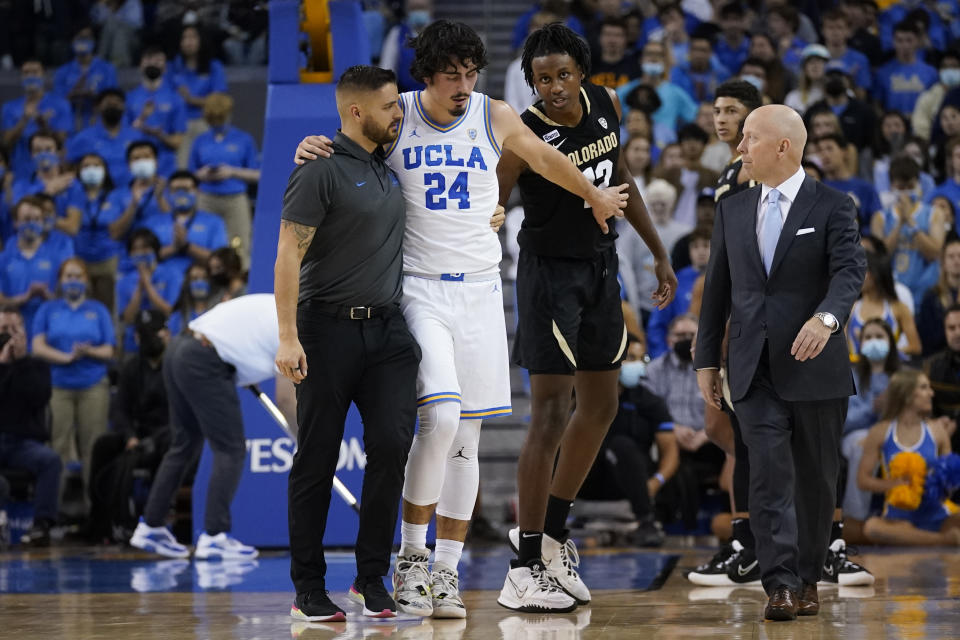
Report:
281,133,406,307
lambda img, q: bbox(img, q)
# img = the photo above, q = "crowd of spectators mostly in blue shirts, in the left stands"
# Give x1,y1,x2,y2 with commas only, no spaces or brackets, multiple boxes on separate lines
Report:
0,7,258,544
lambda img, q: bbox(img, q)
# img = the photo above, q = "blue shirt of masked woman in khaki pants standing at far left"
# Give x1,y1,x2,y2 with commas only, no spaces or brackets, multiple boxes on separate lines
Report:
33,298,116,390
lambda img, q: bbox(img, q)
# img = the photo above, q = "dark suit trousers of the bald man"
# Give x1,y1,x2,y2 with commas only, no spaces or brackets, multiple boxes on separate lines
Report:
734,347,847,594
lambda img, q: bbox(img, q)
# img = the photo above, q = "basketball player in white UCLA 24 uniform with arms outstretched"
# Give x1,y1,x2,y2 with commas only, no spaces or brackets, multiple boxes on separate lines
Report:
296,20,627,617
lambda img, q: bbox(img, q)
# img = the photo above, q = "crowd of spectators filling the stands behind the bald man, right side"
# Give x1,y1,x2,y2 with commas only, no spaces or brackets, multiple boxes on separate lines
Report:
498,0,960,543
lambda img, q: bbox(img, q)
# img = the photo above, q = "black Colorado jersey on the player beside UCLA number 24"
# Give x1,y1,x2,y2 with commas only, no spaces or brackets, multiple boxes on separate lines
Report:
517,82,620,258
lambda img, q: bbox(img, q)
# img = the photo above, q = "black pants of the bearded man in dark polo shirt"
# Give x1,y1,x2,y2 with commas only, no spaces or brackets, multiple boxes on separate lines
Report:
288,302,420,593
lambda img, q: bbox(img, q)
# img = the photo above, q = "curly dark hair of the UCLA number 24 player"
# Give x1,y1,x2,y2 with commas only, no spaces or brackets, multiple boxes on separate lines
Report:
407,20,487,80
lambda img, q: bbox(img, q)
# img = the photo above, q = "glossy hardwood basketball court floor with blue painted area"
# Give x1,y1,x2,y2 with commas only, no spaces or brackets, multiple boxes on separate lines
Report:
0,547,960,640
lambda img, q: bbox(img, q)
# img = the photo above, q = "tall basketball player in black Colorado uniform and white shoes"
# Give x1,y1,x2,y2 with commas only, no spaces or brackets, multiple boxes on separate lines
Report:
497,24,677,611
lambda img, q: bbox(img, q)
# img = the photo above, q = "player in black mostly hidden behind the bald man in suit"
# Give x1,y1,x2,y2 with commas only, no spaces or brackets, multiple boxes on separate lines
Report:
687,80,874,586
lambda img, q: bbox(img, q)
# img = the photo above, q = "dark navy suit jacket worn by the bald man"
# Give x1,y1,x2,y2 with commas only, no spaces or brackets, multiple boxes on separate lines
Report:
694,176,866,402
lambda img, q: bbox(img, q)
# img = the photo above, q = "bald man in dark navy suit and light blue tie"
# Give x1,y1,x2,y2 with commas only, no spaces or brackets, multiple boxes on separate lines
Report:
694,105,866,620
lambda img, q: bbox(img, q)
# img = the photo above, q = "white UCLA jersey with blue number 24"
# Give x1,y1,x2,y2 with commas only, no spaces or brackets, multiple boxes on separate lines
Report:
387,91,501,274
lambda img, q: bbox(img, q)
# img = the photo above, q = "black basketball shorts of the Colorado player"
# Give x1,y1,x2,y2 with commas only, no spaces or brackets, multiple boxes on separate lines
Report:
512,247,627,375
